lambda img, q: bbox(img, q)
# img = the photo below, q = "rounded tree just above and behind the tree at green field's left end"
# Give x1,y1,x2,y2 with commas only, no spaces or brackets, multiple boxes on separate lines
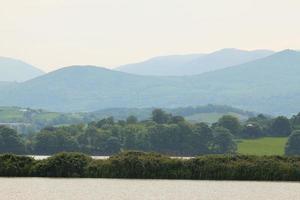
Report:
218,115,241,136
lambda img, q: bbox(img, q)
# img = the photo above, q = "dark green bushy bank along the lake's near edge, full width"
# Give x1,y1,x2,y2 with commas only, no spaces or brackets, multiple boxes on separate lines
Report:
0,152,300,181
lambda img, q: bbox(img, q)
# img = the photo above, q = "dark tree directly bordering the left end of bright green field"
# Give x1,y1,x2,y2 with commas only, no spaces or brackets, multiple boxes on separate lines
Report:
212,127,237,154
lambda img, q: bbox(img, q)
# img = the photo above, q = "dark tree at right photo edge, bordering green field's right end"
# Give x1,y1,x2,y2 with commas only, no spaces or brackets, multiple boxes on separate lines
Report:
285,130,300,155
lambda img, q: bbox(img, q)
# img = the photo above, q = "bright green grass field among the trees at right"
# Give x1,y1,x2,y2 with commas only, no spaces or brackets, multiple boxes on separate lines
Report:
238,137,287,156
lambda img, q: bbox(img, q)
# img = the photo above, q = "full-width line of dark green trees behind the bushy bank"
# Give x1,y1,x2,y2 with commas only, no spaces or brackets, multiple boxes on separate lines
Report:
0,109,300,156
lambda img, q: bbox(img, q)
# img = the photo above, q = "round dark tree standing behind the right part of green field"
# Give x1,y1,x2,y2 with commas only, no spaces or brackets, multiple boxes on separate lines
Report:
270,116,292,136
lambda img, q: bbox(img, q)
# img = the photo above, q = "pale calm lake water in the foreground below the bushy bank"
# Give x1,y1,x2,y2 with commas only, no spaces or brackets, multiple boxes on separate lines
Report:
0,178,300,200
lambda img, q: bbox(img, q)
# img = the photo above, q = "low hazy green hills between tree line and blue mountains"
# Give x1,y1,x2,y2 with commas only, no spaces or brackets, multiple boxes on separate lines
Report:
0,105,255,134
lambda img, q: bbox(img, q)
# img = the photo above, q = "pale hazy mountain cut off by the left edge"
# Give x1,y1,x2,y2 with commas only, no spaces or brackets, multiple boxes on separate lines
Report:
0,57,44,82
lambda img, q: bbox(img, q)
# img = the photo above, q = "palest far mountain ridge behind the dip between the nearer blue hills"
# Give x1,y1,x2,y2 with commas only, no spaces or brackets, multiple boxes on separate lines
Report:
117,49,274,76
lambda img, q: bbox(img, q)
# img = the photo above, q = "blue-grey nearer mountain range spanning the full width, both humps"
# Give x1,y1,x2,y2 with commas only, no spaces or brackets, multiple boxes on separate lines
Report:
0,50,300,114
